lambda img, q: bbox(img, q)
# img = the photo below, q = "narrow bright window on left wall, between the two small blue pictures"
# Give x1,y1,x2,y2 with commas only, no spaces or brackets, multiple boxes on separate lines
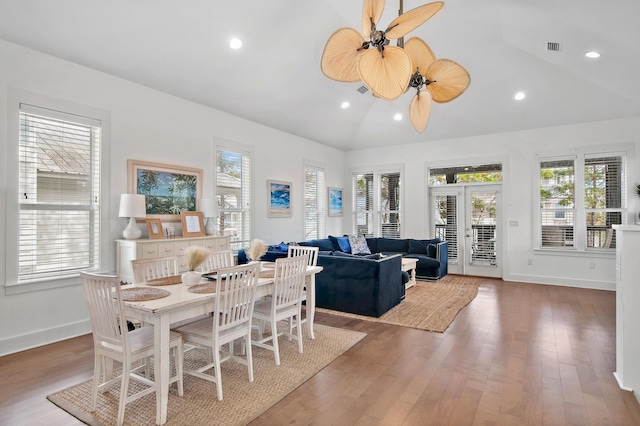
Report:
304,165,325,240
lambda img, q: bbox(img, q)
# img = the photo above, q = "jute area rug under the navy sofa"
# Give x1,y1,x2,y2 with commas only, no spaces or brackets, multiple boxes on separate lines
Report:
316,275,480,333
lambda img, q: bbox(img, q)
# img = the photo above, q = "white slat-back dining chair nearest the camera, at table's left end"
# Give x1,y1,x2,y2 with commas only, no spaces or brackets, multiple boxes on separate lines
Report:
80,272,183,425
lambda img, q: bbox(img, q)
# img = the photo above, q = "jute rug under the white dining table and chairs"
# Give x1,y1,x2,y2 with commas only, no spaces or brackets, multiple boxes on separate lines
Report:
47,324,366,426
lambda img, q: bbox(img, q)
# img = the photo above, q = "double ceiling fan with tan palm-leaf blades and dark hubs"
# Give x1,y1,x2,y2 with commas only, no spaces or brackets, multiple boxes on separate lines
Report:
320,0,471,132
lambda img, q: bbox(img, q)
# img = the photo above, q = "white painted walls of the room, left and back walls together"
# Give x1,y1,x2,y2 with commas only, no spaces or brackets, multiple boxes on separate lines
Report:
0,40,640,356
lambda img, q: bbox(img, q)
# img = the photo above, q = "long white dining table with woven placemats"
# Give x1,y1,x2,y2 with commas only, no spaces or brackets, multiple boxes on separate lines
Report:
122,266,322,425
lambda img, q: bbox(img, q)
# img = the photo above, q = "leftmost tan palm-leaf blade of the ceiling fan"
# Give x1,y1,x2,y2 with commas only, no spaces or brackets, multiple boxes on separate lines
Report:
320,28,364,83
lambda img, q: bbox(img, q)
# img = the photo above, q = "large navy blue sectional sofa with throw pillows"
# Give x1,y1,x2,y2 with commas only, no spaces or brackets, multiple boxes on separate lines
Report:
238,237,447,317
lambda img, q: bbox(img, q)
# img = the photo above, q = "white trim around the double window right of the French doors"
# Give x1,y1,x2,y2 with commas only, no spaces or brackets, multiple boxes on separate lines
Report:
531,143,635,258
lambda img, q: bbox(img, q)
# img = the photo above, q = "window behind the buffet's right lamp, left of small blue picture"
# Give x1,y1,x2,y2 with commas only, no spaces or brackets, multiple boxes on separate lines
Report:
216,149,251,251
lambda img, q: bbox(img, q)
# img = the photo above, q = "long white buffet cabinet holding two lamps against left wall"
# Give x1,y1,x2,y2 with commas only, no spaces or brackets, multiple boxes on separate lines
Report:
116,235,231,283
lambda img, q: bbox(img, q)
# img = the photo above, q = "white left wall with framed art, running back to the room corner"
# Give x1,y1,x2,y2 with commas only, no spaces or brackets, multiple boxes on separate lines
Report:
0,40,344,355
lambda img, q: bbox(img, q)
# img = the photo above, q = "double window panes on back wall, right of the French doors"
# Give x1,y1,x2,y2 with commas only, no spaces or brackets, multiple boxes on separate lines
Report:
540,154,625,250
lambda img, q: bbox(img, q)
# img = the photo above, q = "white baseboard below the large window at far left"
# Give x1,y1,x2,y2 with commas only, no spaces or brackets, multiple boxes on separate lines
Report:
0,319,91,356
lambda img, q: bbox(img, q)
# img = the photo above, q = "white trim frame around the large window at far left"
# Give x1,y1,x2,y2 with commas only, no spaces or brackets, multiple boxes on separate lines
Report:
5,88,113,295
